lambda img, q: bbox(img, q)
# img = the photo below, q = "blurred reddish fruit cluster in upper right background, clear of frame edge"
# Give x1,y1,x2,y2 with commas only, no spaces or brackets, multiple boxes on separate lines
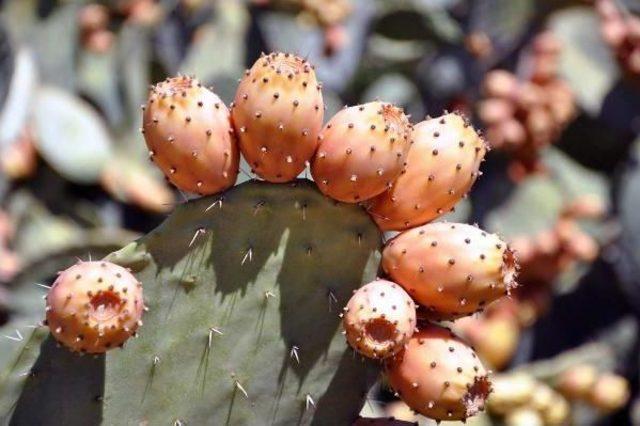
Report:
478,32,576,179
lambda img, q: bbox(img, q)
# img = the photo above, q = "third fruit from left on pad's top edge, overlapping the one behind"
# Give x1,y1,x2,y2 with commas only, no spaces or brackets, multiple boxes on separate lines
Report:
311,102,411,203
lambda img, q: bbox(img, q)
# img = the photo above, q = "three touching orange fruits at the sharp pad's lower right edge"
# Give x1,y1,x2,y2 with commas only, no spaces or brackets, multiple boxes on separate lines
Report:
343,222,518,420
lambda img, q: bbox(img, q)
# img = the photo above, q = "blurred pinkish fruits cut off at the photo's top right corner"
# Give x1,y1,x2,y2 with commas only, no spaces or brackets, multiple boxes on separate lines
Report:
596,0,640,83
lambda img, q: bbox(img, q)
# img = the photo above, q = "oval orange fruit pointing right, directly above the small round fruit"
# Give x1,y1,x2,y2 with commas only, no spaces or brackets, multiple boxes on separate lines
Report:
382,222,519,320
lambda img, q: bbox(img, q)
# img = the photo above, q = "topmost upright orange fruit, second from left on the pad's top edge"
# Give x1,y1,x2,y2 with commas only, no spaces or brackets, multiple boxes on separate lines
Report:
231,53,324,182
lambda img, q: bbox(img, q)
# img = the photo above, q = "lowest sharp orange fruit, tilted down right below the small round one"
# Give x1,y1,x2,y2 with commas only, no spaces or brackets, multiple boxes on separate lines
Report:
385,325,491,420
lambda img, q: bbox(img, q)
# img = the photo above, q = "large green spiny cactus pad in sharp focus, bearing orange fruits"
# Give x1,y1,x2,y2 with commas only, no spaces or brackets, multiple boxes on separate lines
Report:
0,181,381,425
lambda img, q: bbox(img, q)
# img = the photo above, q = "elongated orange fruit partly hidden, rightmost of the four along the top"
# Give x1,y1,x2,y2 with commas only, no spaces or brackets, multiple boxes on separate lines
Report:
368,113,487,231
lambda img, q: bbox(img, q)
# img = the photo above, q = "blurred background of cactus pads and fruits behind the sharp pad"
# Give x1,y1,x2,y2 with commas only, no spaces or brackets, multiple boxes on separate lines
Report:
0,0,640,426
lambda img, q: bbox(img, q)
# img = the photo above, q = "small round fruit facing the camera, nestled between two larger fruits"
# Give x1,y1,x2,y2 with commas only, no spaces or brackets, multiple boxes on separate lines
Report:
342,280,416,359
